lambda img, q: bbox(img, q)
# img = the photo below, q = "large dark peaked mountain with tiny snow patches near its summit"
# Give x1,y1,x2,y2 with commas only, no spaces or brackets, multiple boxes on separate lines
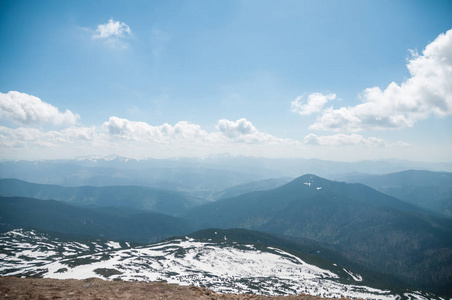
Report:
186,175,452,293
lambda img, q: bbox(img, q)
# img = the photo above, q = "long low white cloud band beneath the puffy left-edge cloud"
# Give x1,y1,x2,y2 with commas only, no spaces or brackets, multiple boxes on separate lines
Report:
0,117,302,159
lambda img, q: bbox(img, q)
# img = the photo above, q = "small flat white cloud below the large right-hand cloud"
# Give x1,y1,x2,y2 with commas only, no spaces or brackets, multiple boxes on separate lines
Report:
304,133,386,148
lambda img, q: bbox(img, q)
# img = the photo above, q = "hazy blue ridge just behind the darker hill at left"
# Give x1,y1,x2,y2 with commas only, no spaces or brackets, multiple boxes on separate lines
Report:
0,179,203,216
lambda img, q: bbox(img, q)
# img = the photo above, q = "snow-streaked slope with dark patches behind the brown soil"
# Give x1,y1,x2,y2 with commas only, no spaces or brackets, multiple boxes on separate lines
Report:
0,229,438,299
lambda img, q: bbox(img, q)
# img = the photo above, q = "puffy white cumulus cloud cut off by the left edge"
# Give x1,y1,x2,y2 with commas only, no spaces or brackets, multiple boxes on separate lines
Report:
0,91,80,126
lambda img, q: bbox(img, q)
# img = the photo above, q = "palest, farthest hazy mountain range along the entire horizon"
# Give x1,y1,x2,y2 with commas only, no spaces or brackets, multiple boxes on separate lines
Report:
0,155,452,192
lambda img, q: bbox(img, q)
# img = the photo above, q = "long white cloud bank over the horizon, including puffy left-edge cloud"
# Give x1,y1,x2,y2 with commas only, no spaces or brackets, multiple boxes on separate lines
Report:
0,92,302,157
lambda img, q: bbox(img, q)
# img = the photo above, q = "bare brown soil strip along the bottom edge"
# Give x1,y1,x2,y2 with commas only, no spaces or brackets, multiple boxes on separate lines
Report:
0,277,354,300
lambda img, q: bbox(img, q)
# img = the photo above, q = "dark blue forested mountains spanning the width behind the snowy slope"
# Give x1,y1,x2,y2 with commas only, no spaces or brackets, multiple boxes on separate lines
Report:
0,164,452,296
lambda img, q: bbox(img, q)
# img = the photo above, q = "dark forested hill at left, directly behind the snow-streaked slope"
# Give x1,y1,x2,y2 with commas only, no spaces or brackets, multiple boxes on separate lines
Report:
0,197,193,243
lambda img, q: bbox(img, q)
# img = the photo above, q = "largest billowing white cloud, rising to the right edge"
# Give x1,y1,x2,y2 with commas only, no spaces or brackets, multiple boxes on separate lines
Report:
308,30,452,132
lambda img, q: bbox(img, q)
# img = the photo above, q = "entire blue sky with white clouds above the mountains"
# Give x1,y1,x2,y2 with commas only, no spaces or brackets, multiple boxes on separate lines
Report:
0,0,452,162
